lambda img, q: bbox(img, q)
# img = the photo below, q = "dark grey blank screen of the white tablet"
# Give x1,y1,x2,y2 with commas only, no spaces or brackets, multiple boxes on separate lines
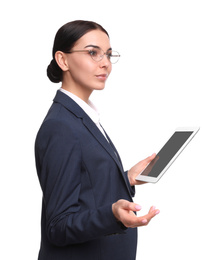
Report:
141,131,193,177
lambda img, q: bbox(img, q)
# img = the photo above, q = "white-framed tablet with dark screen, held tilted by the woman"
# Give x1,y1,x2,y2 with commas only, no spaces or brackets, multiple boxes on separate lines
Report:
136,127,199,183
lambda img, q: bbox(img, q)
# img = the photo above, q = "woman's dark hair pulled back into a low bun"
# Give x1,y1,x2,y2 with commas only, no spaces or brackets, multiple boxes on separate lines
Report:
47,20,109,83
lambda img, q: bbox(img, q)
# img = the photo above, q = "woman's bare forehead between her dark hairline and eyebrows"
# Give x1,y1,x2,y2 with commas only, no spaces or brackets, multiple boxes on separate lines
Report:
75,30,111,50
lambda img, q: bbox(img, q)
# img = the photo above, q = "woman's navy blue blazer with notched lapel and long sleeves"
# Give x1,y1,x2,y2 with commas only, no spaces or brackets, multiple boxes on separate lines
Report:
35,91,137,260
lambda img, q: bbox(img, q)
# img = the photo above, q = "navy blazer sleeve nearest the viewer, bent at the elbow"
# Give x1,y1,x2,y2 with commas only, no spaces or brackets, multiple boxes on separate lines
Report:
35,119,125,246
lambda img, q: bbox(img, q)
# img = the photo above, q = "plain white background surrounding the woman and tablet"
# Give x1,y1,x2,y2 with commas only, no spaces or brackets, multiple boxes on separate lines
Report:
0,0,223,260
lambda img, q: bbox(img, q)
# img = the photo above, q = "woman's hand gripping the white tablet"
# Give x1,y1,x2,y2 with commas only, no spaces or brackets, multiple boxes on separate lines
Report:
128,153,156,186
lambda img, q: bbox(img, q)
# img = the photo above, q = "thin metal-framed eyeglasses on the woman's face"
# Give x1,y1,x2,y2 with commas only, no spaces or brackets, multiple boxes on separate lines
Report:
66,47,121,64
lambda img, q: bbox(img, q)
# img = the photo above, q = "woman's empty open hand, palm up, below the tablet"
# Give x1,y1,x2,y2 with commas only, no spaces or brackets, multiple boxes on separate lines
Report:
112,200,160,228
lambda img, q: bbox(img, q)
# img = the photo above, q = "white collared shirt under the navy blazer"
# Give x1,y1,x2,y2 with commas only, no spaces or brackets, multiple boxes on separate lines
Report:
60,88,108,140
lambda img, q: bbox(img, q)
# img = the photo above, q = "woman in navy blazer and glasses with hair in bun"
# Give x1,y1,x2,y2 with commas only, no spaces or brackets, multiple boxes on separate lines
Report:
35,21,159,260
